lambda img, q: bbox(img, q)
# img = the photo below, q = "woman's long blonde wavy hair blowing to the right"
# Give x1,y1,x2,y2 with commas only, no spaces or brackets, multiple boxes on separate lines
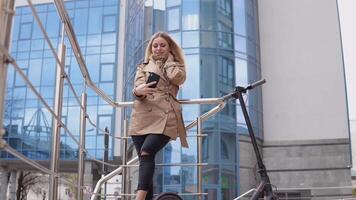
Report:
144,32,185,65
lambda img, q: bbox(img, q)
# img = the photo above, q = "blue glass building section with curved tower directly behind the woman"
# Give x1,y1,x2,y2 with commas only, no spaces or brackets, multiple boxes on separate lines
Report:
124,0,263,200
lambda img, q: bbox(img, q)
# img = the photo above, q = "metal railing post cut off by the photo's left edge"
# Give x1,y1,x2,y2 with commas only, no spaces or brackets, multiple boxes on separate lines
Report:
0,0,15,150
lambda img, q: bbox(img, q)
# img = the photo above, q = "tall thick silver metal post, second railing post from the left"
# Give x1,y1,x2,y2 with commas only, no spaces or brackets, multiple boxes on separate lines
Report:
49,25,66,200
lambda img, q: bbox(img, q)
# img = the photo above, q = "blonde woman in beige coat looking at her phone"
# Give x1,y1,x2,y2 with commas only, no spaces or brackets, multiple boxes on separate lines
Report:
129,32,188,200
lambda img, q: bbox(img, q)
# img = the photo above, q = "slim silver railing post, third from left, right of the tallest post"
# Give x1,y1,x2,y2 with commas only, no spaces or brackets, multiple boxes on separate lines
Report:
78,92,87,199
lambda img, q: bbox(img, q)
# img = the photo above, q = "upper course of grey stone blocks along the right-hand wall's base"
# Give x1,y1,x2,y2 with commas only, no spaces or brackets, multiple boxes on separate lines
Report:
263,139,351,171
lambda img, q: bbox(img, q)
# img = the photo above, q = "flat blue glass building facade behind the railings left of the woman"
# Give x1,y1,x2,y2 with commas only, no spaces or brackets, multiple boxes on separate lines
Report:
1,0,119,160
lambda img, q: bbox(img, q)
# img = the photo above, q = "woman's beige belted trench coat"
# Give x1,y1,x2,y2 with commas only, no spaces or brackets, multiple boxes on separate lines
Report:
129,55,188,147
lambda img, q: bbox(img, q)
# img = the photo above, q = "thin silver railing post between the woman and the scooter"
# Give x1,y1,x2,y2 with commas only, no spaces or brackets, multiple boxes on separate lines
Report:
197,116,203,200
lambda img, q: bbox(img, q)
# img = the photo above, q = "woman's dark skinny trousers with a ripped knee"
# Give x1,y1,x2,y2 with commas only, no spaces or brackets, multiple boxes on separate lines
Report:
132,134,171,200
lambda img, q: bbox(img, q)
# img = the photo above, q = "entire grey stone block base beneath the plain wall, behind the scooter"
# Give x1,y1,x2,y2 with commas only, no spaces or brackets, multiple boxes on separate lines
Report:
263,139,351,197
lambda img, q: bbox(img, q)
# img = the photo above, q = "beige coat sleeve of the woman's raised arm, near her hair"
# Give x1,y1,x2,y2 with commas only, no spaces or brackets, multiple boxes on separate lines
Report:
164,62,186,86
